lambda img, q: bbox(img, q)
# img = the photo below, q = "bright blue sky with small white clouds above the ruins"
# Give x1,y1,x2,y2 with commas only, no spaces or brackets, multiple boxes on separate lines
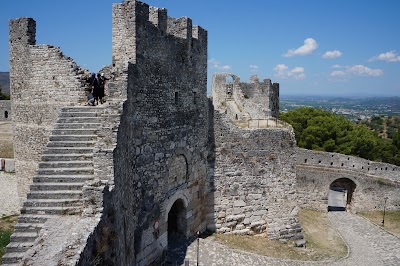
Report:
0,0,400,96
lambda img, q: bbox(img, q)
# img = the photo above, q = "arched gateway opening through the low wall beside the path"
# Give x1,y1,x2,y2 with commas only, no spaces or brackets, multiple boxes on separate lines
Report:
328,178,356,211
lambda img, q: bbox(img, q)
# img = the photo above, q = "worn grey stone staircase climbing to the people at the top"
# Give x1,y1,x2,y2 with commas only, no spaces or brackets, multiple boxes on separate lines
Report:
2,106,103,265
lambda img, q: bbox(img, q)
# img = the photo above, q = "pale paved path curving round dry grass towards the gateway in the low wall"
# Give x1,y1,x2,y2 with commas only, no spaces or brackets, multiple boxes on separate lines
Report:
173,212,400,266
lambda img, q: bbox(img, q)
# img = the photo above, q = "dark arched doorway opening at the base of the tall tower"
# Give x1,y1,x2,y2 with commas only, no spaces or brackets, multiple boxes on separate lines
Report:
168,199,187,240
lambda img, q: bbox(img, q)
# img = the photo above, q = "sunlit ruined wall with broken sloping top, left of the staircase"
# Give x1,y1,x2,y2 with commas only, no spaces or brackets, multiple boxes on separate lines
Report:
10,18,89,203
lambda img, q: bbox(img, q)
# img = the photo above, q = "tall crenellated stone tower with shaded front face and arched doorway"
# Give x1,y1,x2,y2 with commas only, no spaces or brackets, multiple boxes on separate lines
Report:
106,1,207,265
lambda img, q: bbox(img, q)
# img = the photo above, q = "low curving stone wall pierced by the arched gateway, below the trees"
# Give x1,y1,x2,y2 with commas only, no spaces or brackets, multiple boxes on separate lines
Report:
296,149,400,212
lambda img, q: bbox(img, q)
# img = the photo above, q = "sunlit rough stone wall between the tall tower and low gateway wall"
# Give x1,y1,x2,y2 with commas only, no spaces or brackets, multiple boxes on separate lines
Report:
208,109,301,238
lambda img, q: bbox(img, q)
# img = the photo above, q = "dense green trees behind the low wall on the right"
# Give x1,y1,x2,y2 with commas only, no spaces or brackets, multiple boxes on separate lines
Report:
280,107,400,165
